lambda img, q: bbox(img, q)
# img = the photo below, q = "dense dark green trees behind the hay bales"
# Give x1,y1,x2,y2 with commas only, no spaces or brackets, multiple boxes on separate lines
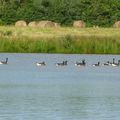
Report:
0,0,120,27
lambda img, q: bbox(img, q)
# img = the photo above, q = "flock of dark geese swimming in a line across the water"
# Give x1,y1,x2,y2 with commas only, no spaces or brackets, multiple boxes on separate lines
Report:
0,58,120,67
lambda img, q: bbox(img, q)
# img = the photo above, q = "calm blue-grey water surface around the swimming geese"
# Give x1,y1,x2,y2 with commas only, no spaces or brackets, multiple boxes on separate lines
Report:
0,54,120,120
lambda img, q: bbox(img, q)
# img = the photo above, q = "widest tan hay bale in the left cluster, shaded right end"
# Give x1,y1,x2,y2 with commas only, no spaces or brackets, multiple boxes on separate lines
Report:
37,21,55,28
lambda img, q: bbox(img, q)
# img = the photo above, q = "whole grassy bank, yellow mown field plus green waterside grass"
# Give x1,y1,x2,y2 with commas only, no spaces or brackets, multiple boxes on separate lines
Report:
0,26,120,54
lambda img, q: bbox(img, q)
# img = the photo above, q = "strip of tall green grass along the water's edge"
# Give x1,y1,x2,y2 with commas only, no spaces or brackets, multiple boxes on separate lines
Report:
0,35,120,54
